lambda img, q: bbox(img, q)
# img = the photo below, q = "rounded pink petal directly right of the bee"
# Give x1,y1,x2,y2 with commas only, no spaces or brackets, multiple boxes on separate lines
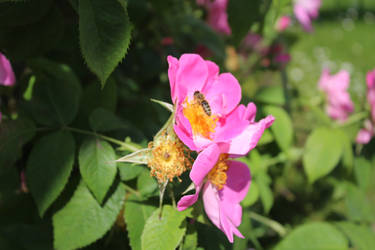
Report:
205,73,241,115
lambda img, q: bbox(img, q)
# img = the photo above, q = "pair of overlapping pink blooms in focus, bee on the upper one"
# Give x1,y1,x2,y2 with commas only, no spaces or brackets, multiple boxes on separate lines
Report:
168,54,274,242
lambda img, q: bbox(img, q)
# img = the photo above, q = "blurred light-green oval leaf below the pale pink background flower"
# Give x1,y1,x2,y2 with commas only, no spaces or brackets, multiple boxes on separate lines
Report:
303,128,343,183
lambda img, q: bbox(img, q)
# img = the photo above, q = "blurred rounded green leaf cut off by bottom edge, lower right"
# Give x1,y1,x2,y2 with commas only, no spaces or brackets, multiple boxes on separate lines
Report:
275,222,348,250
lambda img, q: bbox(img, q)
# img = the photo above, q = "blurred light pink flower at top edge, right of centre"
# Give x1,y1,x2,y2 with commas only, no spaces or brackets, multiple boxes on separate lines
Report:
294,0,321,32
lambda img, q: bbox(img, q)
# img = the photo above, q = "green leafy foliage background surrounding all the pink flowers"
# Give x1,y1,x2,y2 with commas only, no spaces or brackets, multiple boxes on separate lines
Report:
0,0,375,250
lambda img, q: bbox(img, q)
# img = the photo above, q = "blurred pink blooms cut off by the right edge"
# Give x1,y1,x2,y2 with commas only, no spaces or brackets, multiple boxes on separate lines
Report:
356,69,375,144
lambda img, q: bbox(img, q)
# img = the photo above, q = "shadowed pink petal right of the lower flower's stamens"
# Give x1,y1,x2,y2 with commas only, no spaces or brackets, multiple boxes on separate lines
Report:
219,161,251,203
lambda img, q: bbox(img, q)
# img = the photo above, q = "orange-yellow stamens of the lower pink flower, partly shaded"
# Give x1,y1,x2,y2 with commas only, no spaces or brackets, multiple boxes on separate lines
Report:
207,154,229,190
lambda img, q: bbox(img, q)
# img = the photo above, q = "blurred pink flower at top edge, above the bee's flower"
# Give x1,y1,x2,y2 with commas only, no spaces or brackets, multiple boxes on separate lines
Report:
197,0,232,35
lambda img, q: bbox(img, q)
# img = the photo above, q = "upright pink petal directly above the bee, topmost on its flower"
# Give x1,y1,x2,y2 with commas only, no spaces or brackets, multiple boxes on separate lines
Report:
175,54,208,102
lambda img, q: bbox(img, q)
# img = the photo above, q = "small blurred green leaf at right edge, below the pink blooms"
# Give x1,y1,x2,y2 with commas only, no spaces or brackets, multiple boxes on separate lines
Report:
354,157,372,190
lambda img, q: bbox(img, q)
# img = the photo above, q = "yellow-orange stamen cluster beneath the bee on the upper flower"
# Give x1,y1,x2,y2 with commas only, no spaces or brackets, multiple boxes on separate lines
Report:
183,98,218,139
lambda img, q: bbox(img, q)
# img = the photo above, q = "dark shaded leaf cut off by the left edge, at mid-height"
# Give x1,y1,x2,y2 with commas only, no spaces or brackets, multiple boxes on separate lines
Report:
0,118,36,173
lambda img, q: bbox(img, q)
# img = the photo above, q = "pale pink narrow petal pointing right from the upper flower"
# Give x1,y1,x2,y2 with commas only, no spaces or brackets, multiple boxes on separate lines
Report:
227,115,275,155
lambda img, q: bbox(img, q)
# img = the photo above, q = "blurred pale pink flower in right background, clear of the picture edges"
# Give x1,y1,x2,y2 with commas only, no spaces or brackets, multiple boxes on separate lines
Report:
319,69,354,122
